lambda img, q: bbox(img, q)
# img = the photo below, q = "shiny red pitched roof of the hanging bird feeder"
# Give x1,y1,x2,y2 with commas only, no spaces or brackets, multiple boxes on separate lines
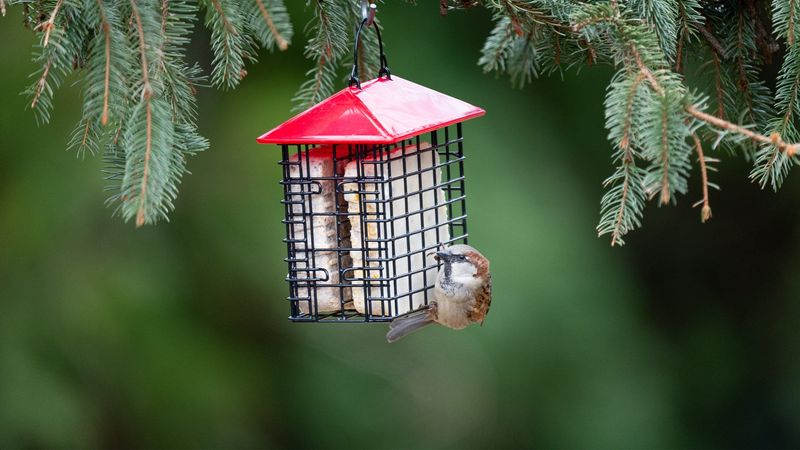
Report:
257,75,486,144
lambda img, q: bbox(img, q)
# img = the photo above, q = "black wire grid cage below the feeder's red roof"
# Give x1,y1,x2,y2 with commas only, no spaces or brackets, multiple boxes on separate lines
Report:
280,123,468,323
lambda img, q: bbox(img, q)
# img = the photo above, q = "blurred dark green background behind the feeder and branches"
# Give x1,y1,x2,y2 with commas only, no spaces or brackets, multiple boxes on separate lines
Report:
0,1,800,448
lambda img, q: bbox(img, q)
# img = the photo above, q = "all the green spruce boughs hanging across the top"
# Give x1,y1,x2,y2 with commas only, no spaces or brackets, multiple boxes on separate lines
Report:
6,0,800,245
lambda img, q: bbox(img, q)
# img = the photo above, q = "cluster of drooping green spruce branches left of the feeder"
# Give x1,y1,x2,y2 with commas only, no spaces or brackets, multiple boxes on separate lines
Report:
5,0,292,226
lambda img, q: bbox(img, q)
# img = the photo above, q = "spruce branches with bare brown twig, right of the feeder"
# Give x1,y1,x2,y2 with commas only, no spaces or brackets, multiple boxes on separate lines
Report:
468,0,800,245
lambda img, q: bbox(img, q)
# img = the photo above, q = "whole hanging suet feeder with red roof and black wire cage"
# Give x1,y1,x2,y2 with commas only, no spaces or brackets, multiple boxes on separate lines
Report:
258,7,485,322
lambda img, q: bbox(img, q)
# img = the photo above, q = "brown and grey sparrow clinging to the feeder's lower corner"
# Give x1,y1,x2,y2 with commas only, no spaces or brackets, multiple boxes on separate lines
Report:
386,244,492,342
